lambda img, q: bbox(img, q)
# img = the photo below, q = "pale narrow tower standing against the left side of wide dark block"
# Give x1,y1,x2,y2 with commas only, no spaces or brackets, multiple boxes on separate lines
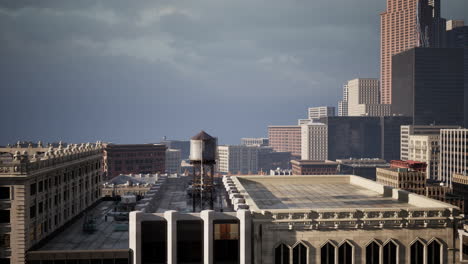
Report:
301,122,328,160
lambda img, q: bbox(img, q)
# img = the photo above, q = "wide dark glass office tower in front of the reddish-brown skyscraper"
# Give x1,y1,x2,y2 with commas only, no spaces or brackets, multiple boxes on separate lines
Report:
392,48,464,126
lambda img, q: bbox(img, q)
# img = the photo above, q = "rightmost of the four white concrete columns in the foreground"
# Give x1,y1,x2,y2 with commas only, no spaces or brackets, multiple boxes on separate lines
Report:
237,209,252,264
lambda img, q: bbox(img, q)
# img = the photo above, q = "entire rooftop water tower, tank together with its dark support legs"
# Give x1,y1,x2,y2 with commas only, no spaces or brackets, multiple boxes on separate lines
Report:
190,131,218,212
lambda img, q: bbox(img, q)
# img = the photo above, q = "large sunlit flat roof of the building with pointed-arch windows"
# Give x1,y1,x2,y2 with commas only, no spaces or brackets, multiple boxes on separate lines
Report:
232,175,454,210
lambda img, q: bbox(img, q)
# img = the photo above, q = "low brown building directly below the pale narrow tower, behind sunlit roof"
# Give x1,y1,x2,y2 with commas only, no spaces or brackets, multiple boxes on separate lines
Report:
291,160,338,175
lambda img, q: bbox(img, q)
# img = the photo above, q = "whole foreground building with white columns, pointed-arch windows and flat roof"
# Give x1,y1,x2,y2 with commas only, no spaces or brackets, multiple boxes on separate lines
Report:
129,175,460,264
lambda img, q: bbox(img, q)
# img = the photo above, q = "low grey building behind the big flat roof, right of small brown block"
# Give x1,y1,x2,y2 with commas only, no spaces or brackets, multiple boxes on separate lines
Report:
336,158,390,181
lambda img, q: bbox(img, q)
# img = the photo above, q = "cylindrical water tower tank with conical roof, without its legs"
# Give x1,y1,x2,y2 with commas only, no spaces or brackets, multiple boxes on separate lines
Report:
190,131,217,163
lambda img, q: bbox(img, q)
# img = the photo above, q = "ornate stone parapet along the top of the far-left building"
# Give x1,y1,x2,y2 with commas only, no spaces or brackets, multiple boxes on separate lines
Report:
0,141,103,175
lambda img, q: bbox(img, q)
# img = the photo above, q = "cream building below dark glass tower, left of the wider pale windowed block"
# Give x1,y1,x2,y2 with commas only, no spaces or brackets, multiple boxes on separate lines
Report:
408,135,440,180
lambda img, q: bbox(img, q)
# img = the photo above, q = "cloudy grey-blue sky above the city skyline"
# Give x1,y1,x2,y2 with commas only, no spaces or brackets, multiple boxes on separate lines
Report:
0,0,468,145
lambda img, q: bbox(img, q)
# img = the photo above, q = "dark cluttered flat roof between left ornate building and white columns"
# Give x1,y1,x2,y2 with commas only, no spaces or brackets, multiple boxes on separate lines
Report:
37,201,129,251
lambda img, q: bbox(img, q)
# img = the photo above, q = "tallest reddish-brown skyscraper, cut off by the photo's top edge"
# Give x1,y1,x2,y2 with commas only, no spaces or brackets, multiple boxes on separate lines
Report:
380,0,445,104
